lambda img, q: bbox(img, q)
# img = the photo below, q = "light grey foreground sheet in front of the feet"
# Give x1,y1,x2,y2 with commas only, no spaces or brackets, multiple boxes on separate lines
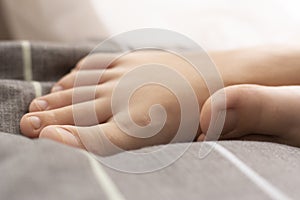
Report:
0,133,300,200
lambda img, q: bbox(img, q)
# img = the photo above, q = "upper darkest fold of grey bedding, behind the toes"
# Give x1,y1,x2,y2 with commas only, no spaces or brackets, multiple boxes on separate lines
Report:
0,41,92,82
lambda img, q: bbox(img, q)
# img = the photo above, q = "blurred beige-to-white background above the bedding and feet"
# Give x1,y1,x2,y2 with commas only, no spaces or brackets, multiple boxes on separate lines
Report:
0,0,300,50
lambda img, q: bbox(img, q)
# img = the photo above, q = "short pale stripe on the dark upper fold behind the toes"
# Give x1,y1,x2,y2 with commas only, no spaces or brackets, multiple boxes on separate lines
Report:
21,41,32,81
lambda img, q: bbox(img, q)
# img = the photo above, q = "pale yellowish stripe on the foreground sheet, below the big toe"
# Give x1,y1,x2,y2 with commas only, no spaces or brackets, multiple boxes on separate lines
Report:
81,151,125,200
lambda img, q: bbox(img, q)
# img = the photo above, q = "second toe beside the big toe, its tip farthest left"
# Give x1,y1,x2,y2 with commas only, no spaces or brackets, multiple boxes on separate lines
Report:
20,98,112,137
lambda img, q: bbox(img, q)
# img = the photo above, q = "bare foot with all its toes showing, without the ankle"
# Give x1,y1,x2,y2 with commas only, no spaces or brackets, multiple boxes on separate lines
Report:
21,51,209,155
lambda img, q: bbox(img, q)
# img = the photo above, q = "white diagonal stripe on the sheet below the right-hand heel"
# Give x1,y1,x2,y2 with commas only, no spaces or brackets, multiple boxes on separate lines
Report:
207,142,291,200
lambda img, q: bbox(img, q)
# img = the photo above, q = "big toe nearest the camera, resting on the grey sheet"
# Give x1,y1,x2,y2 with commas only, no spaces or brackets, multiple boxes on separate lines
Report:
40,121,172,156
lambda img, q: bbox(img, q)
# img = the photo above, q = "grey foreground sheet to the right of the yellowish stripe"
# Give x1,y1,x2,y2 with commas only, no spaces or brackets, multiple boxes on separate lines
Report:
107,141,300,200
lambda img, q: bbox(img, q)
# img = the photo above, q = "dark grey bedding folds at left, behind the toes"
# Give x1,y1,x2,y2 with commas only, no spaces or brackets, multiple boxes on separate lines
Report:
0,41,91,134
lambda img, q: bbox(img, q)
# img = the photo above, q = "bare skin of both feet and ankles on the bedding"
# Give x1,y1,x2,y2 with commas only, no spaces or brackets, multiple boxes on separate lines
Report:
20,47,300,155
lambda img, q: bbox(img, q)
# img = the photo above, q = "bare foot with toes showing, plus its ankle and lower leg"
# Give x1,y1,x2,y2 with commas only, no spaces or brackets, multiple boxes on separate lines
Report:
21,48,300,154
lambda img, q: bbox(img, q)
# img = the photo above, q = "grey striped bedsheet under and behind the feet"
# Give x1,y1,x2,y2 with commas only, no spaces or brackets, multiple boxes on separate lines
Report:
0,42,300,200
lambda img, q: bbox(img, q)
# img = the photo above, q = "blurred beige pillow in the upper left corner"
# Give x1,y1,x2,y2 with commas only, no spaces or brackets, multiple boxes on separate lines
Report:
0,0,105,43
